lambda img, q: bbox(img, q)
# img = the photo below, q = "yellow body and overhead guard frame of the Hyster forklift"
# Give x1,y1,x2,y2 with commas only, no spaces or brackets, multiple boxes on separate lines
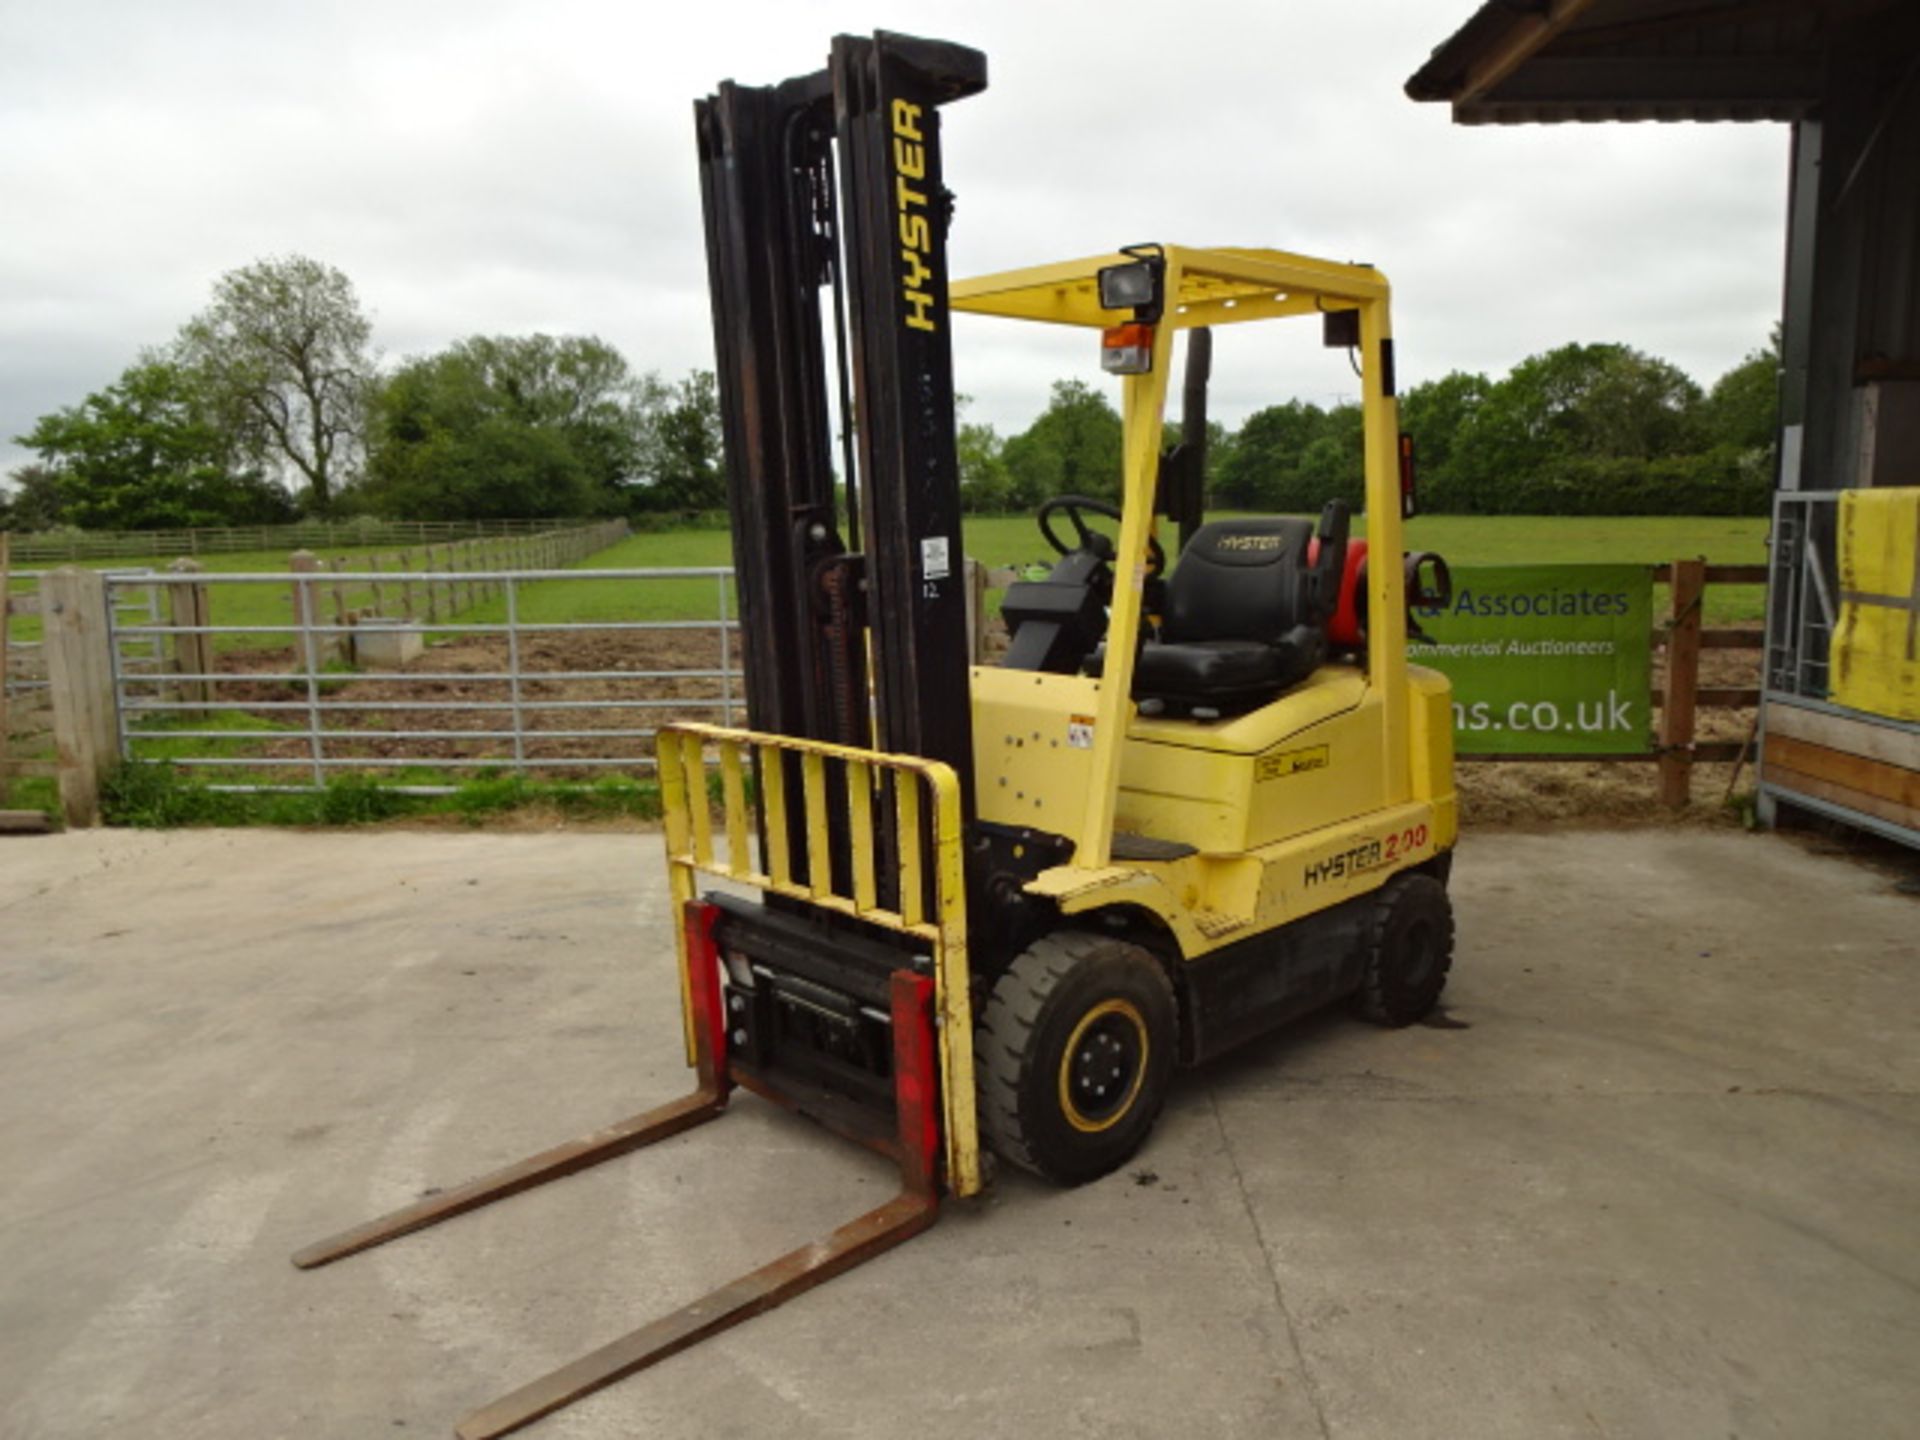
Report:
967,246,1457,960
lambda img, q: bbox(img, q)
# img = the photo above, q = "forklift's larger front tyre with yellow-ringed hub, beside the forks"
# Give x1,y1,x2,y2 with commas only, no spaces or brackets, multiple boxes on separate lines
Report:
973,929,1177,1185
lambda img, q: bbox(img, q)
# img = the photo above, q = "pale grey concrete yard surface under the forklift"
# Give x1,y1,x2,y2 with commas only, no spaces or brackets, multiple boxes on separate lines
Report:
0,831,1920,1440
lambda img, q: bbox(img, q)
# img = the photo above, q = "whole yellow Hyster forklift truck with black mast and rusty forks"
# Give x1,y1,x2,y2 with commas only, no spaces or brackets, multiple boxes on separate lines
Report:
294,33,1455,1440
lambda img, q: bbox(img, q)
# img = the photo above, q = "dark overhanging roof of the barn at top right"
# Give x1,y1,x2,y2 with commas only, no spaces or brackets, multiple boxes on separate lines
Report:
1407,0,1912,125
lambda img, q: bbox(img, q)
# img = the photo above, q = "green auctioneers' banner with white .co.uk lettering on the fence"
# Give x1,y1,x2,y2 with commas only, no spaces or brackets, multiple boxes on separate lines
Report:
1407,564,1653,755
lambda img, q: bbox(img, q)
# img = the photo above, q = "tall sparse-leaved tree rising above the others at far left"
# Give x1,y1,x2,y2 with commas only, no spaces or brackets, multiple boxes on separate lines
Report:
179,255,372,515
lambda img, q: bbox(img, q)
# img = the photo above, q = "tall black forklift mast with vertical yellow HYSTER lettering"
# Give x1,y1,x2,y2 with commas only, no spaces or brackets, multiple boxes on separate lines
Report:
695,33,987,810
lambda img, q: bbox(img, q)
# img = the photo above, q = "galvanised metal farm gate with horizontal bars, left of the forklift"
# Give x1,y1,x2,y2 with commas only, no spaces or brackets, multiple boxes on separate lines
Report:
97,566,745,795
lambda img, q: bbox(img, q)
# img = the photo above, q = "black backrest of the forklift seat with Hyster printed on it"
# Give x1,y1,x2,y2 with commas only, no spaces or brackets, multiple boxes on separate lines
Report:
1160,516,1321,645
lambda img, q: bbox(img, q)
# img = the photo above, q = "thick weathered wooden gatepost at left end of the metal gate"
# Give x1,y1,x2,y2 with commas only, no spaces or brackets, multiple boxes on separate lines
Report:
42,568,119,826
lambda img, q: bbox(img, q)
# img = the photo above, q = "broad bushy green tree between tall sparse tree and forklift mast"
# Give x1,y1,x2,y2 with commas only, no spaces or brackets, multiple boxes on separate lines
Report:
360,334,659,520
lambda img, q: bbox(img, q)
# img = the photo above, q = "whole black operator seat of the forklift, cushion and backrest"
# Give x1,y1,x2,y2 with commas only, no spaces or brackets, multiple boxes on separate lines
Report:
1094,507,1346,718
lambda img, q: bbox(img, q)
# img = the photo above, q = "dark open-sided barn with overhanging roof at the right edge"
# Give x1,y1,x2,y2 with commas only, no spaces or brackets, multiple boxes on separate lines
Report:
1407,0,1920,847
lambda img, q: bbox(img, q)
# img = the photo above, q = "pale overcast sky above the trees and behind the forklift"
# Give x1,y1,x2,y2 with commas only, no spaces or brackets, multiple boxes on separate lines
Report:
0,0,1788,485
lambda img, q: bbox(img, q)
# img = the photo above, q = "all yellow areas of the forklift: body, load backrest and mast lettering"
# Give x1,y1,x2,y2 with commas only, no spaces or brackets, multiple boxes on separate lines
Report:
675,245,1459,1194
